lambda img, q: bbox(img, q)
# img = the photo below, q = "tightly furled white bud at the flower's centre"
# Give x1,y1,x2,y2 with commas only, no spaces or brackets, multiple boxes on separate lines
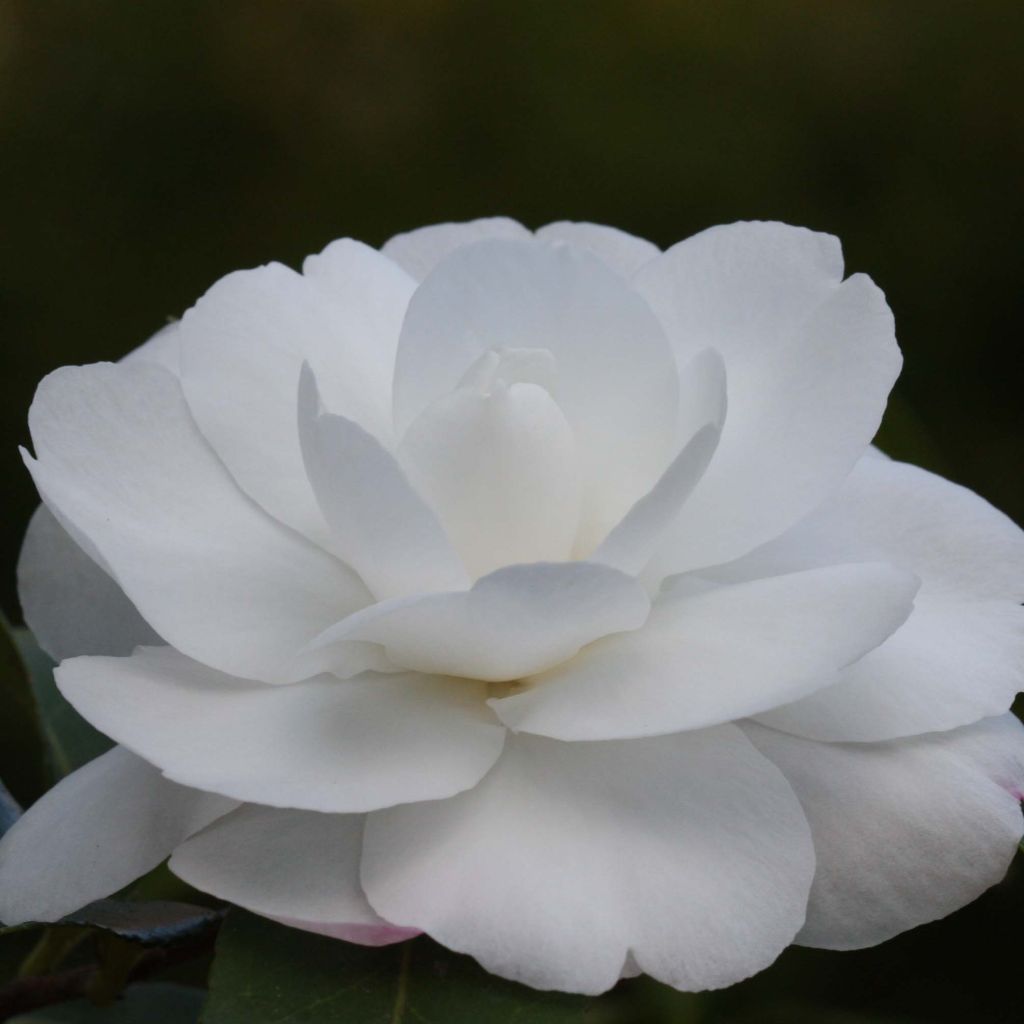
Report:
398,382,580,589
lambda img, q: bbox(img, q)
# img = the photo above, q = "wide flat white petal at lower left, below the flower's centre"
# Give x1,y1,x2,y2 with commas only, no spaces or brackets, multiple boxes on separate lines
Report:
56,647,504,812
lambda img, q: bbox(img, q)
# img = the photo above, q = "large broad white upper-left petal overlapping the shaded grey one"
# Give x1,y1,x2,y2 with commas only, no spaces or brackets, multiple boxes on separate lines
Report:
27,364,370,680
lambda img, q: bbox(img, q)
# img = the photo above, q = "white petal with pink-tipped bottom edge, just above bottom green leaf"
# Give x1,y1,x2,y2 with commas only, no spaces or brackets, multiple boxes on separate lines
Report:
170,804,418,946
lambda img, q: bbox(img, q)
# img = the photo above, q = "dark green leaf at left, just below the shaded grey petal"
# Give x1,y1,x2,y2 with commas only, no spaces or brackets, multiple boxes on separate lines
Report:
11,629,114,781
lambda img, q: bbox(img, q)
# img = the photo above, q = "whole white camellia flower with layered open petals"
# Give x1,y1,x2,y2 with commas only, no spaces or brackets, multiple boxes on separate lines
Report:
0,219,1024,993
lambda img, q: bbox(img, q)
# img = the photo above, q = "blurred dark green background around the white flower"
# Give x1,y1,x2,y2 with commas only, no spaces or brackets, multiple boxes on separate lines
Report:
0,0,1024,1024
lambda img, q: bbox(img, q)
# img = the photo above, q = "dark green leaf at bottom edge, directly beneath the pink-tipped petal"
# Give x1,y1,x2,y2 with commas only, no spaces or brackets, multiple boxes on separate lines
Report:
203,910,588,1024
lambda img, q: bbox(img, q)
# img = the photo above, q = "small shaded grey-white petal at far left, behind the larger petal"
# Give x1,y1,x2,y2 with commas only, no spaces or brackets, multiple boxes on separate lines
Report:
17,505,162,662
